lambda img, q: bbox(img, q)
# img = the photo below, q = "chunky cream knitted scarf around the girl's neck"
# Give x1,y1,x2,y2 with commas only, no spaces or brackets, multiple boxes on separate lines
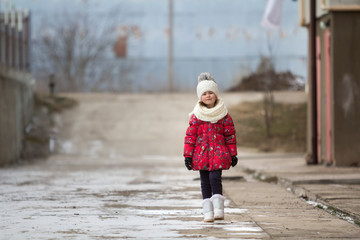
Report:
189,98,228,123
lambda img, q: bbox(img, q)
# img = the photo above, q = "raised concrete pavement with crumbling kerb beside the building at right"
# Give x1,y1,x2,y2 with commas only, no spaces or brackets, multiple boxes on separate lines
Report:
231,149,360,227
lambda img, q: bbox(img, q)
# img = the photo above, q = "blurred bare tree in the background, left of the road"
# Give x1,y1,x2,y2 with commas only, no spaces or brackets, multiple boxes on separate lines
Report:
34,6,130,91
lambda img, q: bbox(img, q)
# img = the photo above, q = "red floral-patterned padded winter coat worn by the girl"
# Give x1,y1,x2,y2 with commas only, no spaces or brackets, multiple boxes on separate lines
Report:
184,114,237,171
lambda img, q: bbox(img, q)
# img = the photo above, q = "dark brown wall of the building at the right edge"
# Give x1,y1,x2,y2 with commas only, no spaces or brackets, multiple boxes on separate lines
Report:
331,12,360,166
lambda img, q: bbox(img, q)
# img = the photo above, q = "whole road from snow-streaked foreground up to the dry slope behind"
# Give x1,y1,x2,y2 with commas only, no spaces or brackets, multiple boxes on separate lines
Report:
0,94,268,239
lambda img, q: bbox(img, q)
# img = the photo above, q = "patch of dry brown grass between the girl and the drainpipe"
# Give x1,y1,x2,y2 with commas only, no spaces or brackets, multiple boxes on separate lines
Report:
229,102,306,152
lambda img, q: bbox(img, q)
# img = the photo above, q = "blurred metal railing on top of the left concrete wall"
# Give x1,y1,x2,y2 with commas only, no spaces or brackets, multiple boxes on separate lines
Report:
0,8,30,71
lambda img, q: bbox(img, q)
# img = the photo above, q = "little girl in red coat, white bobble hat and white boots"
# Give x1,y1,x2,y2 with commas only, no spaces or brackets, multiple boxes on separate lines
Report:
184,72,238,222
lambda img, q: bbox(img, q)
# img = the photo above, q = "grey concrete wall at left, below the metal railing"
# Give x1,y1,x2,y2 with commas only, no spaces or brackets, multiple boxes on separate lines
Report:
0,65,33,165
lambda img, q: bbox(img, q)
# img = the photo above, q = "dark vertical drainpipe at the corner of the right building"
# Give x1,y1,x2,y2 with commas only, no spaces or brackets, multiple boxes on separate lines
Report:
307,0,318,164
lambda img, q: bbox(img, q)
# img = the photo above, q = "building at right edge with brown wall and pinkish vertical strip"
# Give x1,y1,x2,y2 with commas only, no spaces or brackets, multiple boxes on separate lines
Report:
299,0,360,166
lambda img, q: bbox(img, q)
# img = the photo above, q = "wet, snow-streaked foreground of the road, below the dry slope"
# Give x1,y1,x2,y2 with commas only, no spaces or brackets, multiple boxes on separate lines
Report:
0,156,267,239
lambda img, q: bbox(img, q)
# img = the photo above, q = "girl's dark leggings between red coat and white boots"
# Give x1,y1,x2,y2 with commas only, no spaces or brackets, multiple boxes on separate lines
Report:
200,170,222,199
